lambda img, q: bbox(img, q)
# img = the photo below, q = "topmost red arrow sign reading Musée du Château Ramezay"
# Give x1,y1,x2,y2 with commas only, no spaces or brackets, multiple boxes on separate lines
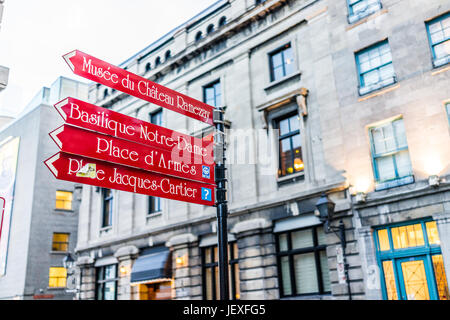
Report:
63,50,214,125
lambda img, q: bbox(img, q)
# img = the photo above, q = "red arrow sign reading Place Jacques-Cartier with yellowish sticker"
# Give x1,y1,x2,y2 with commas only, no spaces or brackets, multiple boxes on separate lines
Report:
44,152,215,206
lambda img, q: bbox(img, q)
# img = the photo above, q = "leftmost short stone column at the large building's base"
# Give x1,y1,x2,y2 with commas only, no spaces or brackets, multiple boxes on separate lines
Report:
76,256,95,300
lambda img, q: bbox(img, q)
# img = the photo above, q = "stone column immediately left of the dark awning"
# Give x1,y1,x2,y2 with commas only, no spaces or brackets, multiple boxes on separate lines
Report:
114,246,139,300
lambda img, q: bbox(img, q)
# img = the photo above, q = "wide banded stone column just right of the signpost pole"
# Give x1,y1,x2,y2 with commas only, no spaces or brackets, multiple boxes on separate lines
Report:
231,218,279,300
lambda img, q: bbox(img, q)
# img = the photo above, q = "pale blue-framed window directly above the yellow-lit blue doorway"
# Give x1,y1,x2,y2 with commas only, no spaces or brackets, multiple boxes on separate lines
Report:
369,119,414,190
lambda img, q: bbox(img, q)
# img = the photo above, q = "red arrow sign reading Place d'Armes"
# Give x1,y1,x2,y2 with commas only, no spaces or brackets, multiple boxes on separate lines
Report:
50,124,214,184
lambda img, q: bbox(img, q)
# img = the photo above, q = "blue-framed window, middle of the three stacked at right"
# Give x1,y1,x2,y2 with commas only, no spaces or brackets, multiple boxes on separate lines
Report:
356,40,396,95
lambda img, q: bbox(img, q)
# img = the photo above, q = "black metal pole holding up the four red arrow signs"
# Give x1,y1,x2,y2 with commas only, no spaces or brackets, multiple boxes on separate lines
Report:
214,107,230,301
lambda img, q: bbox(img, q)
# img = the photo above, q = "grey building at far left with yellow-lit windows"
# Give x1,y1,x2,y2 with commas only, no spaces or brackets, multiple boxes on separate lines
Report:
0,77,88,300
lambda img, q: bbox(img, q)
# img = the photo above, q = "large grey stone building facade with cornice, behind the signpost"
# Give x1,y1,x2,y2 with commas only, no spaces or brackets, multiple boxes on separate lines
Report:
76,0,450,300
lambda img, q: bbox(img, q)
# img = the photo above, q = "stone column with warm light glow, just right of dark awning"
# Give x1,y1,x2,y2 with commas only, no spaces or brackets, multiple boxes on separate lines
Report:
166,233,202,300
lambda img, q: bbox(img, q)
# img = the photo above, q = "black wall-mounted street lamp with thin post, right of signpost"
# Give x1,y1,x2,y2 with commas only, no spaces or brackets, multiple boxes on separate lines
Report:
316,193,352,300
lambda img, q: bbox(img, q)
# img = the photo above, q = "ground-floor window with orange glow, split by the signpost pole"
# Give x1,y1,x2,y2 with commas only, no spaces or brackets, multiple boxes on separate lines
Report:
202,242,241,300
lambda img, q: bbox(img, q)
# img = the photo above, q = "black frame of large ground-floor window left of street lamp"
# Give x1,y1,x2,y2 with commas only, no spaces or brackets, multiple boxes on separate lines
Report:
275,225,331,298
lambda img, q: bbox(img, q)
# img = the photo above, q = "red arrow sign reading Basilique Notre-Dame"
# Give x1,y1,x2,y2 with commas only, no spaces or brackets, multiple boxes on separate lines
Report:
55,98,214,165
